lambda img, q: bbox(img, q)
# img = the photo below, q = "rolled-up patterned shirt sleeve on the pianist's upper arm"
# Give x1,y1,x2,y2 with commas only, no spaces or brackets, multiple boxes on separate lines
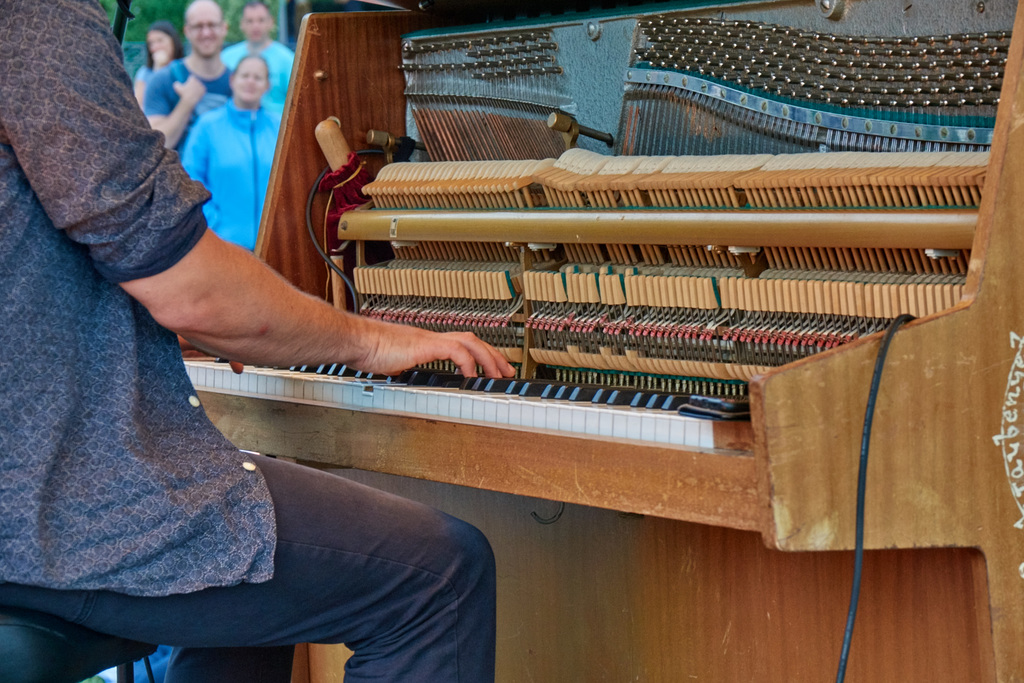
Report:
0,0,209,283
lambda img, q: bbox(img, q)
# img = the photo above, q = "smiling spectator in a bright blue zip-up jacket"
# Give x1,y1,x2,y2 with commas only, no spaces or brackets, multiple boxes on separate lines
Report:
181,55,281,250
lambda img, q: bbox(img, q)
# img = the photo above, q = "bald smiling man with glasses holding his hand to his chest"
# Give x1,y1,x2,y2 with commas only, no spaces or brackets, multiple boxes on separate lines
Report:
142,0,231,150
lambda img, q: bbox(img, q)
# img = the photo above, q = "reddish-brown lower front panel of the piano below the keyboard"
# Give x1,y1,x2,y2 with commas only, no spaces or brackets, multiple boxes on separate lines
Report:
299,471,991,683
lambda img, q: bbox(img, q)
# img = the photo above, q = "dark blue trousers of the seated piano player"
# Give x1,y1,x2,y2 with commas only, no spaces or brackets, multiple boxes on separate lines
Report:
0,457,495,683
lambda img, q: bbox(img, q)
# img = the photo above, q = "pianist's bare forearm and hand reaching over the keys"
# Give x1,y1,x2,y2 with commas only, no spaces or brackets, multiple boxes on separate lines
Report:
122,230,514,377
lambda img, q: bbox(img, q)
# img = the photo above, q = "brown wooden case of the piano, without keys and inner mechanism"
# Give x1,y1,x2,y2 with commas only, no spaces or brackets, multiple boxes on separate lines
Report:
202,2,1024,683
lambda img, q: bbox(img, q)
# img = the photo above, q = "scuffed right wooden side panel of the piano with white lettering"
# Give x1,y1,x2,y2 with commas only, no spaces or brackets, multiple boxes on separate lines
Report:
752,3,1024,681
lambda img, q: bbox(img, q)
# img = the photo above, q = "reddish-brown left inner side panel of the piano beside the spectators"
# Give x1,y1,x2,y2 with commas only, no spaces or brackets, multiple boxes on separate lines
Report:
256,12,437,297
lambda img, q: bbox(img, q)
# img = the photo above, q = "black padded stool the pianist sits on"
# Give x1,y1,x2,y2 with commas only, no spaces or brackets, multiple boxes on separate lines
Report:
0,607,157,683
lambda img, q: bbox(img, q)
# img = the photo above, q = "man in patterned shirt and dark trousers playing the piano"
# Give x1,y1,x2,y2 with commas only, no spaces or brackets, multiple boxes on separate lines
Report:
0,0,512,683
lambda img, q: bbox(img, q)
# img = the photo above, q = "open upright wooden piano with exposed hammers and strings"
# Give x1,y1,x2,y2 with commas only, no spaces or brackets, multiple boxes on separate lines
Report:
190,0,1024,683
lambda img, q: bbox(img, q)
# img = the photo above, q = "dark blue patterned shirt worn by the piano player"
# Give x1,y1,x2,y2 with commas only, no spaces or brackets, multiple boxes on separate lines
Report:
0,0,275,596
